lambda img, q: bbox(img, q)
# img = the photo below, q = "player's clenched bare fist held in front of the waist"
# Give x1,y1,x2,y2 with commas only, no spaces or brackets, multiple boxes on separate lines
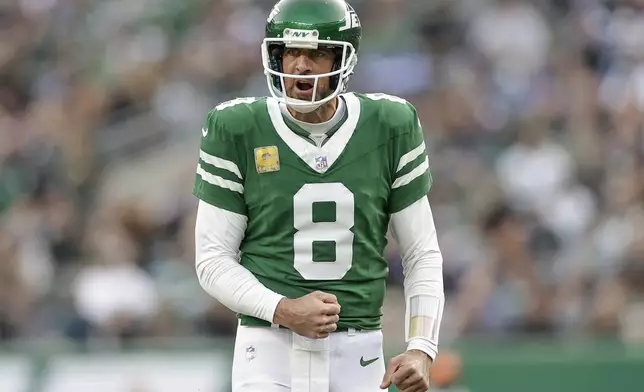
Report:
273,291,340,339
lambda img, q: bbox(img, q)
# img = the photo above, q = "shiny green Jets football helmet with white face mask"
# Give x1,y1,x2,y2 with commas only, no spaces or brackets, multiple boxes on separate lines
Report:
262,0,362,113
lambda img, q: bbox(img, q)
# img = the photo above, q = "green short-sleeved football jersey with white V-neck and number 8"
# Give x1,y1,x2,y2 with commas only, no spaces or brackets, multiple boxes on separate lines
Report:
194,93,431,329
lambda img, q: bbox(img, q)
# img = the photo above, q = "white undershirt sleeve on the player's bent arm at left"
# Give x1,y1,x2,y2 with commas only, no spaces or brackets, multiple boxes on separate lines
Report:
195,201,284,323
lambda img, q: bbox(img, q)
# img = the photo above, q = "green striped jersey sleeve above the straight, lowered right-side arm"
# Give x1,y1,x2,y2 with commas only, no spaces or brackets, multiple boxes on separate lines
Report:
389,105,432,214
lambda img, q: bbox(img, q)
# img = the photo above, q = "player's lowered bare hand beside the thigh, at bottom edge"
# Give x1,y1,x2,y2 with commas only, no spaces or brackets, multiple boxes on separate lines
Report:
380,350,432,392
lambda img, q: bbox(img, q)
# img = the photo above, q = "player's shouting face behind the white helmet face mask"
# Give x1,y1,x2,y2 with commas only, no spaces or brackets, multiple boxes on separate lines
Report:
282,48,335,101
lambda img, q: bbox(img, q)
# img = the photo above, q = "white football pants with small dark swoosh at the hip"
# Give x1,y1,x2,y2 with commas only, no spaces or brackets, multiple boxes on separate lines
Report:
232,326,385,392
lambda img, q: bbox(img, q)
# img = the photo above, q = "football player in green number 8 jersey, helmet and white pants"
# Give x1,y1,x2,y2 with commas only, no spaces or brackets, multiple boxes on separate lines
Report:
194,0,444,392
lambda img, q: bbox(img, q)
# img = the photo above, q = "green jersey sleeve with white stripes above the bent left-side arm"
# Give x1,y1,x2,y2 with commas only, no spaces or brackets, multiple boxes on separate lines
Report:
193,110,247,215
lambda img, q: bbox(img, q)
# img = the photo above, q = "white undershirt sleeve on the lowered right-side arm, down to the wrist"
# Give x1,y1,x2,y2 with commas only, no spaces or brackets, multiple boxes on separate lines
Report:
391,197,445,359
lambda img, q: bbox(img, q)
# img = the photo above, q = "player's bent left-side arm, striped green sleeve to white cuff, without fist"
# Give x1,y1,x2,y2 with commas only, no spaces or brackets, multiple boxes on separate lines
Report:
193,110,283,322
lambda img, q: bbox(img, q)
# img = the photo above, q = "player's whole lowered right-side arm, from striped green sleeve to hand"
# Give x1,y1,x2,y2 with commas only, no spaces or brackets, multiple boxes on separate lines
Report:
380,105,444,391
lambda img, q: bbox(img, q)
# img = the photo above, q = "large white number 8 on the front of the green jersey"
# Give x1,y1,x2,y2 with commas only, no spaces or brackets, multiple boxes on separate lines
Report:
293,183,354,280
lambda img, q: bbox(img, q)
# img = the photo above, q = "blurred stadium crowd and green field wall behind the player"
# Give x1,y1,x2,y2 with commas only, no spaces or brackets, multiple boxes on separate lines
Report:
0,0,644,392
